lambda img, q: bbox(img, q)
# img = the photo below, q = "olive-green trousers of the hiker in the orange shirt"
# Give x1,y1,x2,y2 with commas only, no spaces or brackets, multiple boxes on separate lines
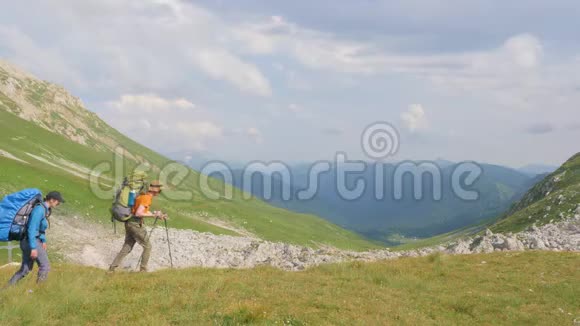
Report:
109,220,151,272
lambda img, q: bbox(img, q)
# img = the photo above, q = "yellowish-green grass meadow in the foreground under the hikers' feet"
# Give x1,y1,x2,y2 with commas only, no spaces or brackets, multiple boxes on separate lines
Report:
0,252,580,325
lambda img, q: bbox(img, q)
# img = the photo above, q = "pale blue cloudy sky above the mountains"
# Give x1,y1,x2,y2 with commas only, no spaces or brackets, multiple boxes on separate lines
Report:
0,0,580,166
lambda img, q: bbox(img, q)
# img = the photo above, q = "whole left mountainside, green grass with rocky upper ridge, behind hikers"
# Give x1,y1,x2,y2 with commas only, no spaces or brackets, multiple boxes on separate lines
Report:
0,61,375,249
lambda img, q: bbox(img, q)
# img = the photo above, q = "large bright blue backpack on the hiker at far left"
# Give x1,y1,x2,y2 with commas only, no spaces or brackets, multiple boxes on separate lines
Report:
0,189,42,241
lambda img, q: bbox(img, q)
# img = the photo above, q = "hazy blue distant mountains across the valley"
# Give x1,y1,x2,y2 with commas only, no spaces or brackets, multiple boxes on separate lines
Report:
214,161,539,244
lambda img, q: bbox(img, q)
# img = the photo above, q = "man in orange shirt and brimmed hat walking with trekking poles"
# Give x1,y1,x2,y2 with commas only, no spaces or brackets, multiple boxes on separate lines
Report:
109,181,167,272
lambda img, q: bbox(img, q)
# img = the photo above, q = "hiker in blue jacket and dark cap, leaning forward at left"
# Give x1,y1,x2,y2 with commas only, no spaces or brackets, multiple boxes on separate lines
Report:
9,191,64,285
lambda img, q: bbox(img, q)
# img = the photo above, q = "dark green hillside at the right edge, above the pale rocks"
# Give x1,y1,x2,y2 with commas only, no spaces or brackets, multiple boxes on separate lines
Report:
490,153,580,232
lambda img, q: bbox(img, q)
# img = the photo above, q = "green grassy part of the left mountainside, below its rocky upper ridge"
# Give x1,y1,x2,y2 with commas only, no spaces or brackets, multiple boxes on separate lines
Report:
0,94,374,249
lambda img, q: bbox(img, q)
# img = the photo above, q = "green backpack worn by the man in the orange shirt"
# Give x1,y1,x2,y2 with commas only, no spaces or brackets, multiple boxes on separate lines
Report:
111,171,147,222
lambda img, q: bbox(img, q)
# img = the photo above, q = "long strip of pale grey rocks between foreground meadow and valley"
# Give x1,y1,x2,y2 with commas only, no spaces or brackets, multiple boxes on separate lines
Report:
48,216,580,271
